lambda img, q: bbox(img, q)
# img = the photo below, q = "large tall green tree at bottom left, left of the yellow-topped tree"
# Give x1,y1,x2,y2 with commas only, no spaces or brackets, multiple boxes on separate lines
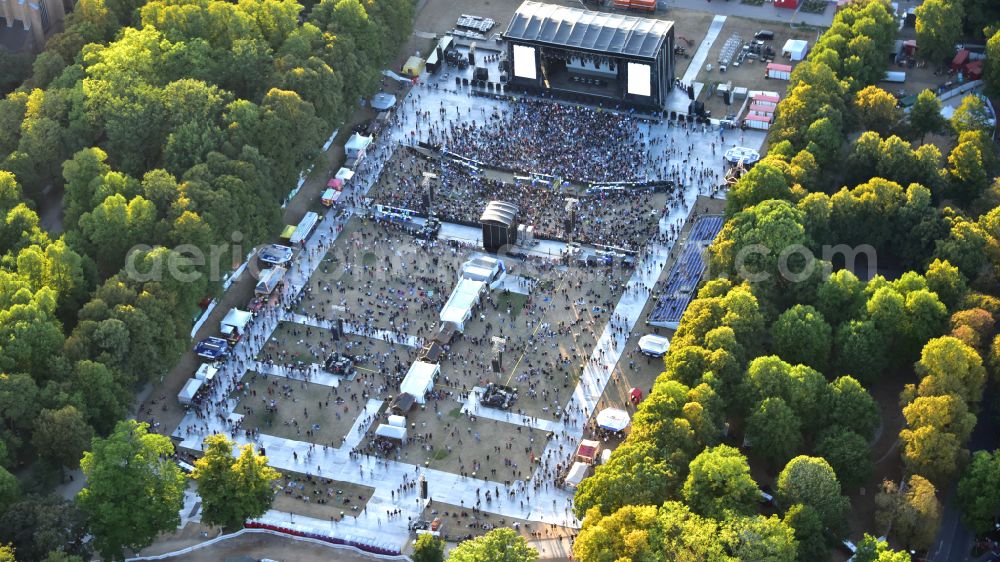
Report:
77,420,184,560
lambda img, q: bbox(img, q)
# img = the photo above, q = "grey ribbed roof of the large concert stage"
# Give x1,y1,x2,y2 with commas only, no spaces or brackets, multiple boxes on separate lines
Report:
503,1,674,58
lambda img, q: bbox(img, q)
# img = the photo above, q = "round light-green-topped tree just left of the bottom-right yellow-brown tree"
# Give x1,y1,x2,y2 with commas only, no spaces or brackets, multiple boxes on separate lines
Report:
778,455,850,529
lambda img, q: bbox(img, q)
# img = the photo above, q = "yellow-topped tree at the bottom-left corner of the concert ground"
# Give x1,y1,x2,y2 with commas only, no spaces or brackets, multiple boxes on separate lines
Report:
191,433,280,529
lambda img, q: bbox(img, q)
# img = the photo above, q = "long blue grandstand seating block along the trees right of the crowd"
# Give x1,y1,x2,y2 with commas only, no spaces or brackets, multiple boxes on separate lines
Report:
648,216,724,325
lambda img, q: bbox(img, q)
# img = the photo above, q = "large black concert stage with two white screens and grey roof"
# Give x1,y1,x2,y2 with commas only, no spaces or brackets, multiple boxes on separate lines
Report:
503,1,674,110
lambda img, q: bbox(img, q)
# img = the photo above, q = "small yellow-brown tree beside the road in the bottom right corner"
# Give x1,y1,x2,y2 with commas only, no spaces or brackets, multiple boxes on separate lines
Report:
875,474,941,550
